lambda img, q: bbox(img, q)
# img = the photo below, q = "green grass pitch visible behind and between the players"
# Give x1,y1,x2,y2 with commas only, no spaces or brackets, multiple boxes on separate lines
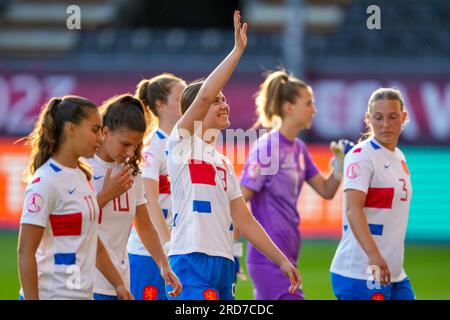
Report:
0,232,450,300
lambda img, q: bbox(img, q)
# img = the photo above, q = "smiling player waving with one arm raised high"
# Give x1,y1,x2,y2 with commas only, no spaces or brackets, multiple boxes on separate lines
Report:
167,11,301,300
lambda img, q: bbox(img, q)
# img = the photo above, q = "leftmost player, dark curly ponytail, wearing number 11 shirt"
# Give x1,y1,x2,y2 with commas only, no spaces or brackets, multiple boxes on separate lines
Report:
18,96,132,300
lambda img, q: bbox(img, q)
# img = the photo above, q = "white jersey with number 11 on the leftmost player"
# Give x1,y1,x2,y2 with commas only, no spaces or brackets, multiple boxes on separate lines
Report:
20,158,99,300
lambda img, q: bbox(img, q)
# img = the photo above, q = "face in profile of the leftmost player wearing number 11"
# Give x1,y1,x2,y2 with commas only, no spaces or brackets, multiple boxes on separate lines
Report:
73,110,102,158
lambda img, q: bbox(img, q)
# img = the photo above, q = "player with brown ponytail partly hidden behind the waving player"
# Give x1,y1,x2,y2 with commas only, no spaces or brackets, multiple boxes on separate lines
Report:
128,73,186,300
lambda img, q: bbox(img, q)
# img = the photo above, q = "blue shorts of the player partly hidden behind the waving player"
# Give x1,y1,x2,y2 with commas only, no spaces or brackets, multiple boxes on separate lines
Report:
128,253,167,300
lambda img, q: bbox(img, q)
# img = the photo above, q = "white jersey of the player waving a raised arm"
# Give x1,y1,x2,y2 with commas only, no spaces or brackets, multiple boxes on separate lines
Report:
167,123,242,261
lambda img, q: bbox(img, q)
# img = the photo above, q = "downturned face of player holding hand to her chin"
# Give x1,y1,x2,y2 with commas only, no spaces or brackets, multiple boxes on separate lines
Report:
102,127,144,163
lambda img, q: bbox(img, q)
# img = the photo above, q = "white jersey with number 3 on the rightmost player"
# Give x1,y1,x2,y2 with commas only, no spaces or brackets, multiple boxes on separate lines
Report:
331,138,412,282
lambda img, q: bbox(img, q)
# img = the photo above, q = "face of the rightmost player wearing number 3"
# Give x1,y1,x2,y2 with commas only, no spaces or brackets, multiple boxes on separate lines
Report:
366,100,407,150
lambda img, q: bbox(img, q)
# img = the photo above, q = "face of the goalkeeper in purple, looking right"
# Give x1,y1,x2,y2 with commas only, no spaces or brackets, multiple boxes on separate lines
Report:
288,87,317,129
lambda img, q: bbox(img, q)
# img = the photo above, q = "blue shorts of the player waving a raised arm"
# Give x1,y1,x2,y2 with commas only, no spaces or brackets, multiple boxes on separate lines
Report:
167,252,236,300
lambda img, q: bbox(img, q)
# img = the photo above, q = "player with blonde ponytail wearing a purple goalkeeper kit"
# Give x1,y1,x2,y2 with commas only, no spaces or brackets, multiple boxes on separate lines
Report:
240,70,344,300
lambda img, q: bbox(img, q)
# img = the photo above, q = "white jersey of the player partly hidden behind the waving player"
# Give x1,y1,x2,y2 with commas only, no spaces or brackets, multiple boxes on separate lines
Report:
128,128,173,256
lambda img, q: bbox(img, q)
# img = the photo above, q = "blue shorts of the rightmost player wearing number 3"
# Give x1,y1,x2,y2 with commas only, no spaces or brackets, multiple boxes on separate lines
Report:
331,273,416,300
